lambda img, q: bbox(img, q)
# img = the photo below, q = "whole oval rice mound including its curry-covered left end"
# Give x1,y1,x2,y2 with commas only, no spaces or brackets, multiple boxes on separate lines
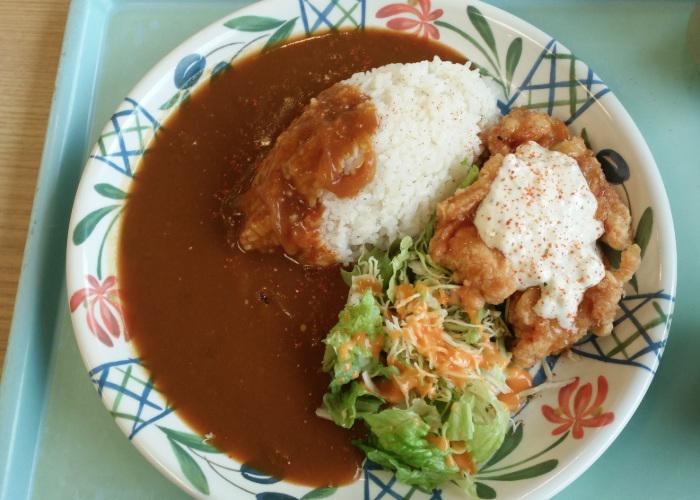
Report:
237,58,497,265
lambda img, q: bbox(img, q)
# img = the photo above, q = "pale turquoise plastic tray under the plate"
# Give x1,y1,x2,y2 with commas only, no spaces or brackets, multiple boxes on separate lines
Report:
0,0,700,500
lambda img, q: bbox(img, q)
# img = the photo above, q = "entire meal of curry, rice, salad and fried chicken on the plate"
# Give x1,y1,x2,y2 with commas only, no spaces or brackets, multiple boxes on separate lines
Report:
119,30,640,494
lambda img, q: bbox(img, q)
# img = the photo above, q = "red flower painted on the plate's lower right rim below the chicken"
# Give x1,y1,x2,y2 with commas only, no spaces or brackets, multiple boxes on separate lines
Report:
542,375,615,439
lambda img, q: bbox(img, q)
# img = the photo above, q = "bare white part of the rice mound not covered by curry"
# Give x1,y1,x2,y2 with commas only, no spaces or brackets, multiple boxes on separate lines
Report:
321,57,498,262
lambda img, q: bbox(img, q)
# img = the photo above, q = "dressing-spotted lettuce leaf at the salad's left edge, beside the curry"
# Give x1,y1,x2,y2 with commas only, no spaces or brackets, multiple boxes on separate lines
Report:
323,290,384,392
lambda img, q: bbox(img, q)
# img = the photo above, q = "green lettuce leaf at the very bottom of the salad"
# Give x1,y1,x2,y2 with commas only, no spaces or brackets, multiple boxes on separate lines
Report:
356,408,461,490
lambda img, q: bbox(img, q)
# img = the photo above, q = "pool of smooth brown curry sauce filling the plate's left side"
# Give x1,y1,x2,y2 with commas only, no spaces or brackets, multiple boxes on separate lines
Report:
119,30,464,486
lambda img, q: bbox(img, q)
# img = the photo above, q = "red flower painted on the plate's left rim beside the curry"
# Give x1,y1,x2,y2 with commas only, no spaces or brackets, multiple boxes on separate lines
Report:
70,275,129,347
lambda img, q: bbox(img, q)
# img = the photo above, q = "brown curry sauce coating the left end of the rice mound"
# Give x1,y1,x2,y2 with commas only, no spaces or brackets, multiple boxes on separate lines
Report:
238,83,378,266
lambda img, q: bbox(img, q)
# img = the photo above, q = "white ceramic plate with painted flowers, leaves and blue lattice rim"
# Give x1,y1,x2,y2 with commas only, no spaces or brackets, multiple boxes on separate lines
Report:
67,0,676,499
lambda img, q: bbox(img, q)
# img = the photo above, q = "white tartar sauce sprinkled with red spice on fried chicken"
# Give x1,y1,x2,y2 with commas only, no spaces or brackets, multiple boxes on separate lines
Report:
474,142,605,330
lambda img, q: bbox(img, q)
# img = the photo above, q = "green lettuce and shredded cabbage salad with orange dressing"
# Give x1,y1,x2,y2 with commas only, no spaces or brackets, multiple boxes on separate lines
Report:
318,194,511,494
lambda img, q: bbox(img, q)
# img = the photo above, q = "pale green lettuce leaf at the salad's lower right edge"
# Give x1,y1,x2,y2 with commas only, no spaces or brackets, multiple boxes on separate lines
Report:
442,382,510,464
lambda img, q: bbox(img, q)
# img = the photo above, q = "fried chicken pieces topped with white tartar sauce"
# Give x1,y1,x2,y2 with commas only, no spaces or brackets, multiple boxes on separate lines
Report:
431,109,640,367
